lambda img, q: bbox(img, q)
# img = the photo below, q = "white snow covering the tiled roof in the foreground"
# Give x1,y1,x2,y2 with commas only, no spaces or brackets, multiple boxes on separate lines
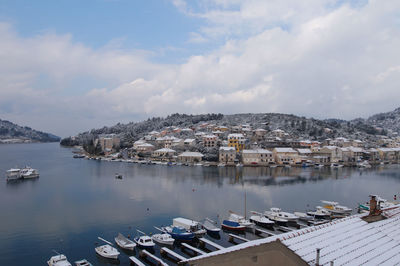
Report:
185,205,400,265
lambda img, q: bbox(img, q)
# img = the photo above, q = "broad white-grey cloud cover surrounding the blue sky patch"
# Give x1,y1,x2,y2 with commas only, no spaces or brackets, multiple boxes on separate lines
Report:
0,0,400,136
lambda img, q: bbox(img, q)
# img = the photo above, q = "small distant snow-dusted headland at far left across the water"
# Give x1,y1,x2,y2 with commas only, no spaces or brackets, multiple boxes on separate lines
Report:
0,119,60,143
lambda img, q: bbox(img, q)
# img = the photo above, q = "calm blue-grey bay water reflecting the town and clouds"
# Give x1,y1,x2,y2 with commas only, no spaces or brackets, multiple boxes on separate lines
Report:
0,144,400,265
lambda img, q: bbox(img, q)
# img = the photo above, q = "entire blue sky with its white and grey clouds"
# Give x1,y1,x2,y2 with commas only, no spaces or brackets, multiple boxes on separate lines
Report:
0,0,400,137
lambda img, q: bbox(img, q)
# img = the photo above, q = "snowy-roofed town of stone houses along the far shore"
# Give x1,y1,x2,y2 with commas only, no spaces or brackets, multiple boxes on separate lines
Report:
73,122,400,167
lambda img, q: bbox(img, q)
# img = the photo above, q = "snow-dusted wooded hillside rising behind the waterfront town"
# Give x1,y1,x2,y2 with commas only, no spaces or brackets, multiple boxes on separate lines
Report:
61,108,400,147
